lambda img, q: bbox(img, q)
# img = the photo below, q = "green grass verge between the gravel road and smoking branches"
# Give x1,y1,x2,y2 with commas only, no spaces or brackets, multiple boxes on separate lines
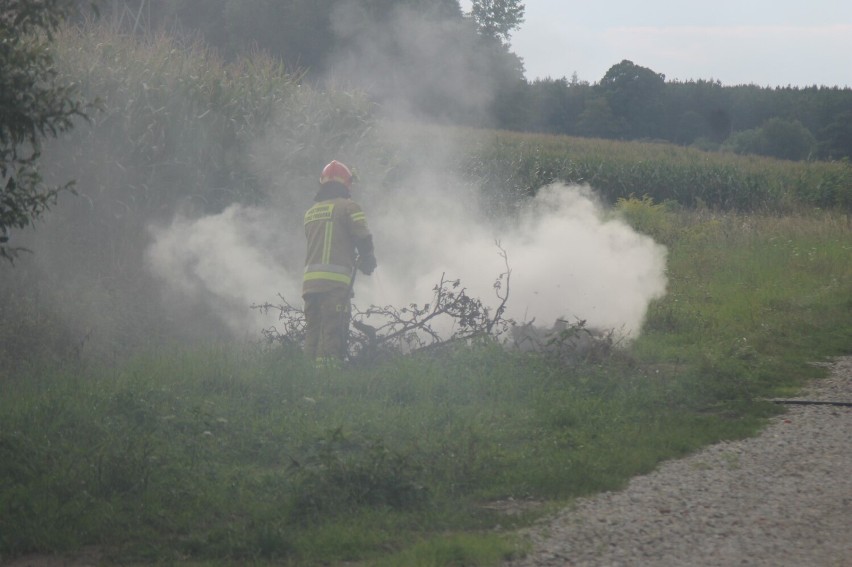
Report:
0,210,852,565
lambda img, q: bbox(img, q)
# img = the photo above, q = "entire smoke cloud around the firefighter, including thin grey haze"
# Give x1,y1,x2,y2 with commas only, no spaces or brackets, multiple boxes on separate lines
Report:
10,10,666,364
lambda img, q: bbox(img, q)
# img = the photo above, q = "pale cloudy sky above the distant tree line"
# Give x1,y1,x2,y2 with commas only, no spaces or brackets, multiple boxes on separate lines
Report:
461,0,852,87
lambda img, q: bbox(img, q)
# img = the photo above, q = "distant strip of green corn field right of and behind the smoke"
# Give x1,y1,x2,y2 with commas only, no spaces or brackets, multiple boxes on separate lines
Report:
446,130,852,213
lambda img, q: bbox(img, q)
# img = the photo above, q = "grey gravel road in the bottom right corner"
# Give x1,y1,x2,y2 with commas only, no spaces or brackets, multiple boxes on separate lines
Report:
506,357,852,567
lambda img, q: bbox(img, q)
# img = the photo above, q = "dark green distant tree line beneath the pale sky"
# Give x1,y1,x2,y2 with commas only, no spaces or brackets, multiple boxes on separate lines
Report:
505,64,852,160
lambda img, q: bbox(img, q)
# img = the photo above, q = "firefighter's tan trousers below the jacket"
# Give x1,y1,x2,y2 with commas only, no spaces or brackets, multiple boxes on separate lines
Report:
304,287,352,366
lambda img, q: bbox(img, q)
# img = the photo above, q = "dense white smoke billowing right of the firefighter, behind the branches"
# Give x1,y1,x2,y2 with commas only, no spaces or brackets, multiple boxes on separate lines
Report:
357,180,666,335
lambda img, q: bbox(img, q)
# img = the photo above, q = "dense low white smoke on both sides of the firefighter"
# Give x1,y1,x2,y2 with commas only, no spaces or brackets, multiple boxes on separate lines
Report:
148,172,666,336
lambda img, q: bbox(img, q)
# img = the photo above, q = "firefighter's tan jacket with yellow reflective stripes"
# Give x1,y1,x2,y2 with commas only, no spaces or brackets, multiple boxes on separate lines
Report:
302,198,373,295
